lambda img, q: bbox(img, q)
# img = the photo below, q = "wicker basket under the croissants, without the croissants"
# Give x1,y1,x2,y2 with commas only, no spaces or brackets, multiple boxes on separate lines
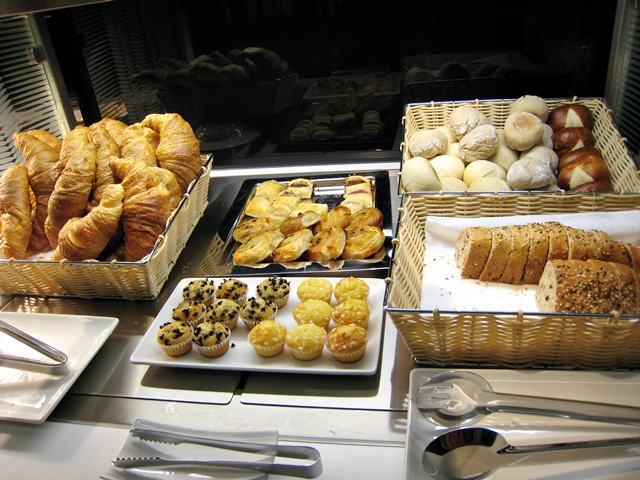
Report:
0,157,211,300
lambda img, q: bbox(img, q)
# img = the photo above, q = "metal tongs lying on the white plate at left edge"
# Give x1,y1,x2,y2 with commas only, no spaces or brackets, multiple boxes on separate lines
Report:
0,320,70,375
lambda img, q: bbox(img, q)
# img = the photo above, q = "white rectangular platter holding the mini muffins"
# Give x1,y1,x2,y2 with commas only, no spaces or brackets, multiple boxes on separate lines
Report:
131,277,385,375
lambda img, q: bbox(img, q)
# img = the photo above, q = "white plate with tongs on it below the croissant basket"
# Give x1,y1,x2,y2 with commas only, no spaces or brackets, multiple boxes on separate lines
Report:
0,312,118,423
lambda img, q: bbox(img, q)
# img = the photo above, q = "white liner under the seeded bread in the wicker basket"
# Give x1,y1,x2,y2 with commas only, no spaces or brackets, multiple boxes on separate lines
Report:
421,210,640,312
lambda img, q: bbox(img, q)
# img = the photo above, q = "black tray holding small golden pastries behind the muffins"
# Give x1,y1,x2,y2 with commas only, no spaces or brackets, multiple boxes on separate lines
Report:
198,171,393,277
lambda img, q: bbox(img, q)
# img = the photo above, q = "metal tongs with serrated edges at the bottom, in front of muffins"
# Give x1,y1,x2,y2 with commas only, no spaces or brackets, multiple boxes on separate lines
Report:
112,427,322,478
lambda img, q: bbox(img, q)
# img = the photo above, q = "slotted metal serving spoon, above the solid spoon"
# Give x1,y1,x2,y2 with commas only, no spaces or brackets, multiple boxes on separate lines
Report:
414,371,640,426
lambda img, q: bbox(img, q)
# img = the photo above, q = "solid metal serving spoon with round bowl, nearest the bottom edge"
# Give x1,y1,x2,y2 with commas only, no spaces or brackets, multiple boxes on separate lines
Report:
422,428,640,480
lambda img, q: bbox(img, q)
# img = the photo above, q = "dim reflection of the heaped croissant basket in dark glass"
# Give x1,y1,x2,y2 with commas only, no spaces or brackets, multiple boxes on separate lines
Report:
131,47,298,128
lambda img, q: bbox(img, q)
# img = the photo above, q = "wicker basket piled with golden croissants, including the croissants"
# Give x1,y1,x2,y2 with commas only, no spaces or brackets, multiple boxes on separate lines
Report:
0,113,211,300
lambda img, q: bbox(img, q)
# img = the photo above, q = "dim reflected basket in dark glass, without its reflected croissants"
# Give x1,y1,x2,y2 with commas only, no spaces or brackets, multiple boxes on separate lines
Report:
156,74,298,129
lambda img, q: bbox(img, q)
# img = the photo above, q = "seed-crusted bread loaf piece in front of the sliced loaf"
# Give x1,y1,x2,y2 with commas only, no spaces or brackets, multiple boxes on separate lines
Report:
536,260,640,313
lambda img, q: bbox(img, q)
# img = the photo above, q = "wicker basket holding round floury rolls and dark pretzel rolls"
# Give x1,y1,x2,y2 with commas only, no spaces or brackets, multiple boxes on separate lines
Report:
399,98,640,203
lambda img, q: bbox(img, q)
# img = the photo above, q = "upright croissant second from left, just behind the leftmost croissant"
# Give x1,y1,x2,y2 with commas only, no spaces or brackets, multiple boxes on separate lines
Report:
13,130,62,253
